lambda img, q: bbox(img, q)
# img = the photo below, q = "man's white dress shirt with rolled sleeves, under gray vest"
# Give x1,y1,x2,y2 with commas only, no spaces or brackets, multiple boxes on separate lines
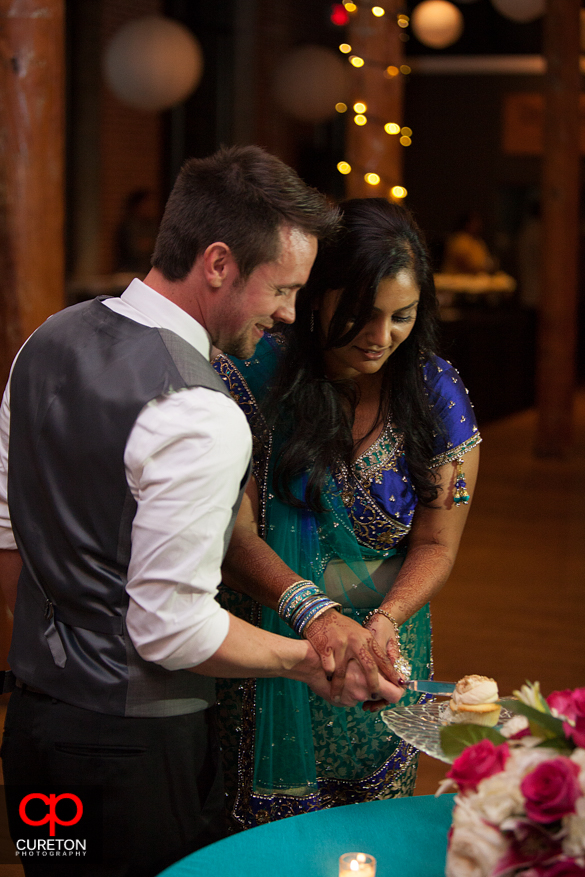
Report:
0,280,252,670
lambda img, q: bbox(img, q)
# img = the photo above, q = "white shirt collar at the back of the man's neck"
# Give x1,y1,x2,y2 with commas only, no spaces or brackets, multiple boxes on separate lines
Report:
120,278,211,360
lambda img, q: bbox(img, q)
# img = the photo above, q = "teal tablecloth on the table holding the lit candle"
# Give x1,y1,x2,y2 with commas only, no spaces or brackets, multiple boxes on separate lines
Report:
161,795,453,877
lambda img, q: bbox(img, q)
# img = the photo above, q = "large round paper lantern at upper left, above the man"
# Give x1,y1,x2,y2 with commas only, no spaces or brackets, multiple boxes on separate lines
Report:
103,15,203,112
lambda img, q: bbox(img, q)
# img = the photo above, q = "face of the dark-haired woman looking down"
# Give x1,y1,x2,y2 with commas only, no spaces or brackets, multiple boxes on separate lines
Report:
318,269,420,379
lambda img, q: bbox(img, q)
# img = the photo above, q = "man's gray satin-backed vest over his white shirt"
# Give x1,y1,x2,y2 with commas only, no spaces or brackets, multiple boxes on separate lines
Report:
8,300,249,716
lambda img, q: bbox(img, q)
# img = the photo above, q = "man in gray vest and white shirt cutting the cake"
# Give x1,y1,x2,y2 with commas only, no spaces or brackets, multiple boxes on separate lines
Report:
0,147,395,877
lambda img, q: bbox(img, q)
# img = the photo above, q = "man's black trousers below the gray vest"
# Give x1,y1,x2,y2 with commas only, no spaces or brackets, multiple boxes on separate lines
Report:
1,688,225,877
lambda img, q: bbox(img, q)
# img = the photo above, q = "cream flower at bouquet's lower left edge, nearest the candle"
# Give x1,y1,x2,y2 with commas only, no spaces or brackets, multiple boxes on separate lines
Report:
445,798,508,877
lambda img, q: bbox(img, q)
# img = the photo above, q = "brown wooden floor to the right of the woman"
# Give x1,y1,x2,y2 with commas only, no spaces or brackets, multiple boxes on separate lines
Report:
0,392,585,877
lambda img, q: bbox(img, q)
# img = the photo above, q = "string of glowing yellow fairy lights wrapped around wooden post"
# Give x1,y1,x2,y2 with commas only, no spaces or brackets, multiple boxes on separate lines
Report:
335,0,412,200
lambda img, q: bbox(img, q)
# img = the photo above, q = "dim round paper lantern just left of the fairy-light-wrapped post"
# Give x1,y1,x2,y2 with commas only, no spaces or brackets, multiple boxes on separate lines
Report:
273,45,348,122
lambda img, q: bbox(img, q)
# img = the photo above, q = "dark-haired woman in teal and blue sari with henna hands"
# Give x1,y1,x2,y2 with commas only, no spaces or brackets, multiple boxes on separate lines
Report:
214,198,481,828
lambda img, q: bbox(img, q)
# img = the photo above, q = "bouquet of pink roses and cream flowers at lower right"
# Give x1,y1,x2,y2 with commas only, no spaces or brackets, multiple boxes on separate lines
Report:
437,683,585,877
